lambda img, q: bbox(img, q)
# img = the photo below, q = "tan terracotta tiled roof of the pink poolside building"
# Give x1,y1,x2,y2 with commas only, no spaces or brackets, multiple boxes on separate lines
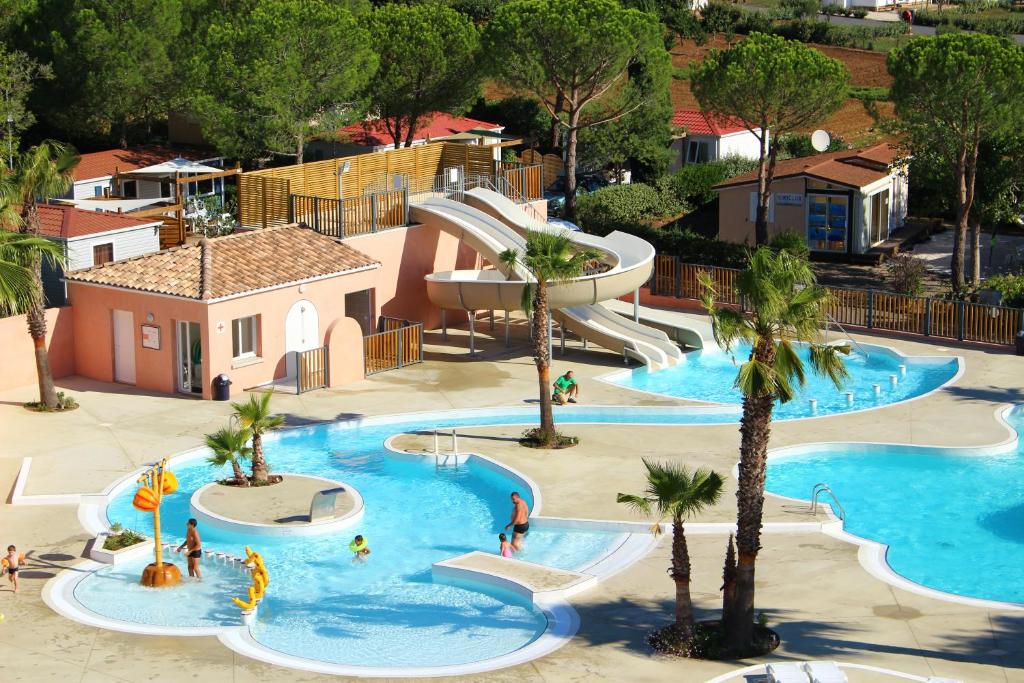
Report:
67,225,380,300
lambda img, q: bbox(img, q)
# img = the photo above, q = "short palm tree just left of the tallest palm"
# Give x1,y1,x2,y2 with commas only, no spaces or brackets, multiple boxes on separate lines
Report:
615,458,723,637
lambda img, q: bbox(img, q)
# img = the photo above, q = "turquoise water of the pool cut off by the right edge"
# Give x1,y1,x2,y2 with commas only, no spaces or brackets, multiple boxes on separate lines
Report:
766,408,1024,603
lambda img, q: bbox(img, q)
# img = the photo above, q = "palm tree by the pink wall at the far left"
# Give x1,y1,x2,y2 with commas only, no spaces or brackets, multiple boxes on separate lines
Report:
0,140,79,409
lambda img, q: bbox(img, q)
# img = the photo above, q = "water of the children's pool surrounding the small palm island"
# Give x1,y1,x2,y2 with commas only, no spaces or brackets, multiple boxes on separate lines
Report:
81,409,647,667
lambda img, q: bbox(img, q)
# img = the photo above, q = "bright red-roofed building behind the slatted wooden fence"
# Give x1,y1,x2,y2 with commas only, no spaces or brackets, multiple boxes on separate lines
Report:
305,112,505,160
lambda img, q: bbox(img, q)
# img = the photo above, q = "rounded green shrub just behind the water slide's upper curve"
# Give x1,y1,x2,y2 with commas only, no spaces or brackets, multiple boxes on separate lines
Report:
577,182,680,234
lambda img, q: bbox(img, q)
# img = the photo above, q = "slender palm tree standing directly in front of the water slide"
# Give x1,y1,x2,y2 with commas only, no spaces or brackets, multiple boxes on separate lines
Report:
501,231,600,446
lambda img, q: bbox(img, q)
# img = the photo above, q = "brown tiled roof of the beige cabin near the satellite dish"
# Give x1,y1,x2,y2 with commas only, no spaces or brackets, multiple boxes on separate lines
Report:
715,142,899,189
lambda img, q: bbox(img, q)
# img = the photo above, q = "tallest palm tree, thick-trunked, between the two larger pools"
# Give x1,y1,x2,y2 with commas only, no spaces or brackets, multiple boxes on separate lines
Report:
700,247,850,654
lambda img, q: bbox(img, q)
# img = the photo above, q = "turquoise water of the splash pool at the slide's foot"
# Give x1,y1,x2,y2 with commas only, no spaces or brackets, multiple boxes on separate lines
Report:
608,344,958,418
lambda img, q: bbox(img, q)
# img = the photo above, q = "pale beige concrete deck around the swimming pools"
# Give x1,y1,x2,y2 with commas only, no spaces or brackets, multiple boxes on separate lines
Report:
0,313,1024,682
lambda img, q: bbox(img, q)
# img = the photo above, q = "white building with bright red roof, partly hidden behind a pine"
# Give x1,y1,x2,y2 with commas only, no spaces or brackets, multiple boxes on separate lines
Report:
671,110,761,171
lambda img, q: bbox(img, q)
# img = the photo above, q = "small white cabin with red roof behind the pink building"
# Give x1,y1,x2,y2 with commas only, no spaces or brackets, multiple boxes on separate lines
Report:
5,204,163,306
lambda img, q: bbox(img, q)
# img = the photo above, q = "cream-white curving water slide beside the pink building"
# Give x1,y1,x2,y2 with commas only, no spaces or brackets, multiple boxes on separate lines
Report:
410,188,682,370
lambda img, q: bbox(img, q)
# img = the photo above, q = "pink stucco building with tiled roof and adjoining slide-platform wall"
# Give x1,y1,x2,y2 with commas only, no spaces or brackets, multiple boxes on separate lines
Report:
67,225,477,398
